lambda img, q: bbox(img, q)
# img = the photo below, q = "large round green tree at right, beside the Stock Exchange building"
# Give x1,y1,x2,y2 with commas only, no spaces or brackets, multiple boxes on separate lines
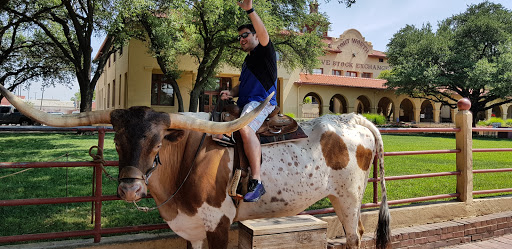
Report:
383,1,512,124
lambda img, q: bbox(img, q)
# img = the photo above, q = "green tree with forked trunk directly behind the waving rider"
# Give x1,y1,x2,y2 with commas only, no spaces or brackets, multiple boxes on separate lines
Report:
124,0,348,111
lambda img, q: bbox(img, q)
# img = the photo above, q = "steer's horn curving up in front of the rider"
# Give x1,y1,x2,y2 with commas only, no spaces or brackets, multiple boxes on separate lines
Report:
170,92,274,134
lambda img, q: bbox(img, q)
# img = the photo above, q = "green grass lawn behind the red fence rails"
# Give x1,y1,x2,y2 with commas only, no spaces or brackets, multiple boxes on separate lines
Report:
0,133,512,242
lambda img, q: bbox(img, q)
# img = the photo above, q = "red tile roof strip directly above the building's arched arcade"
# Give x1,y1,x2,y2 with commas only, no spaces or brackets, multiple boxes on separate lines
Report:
295,73,387,89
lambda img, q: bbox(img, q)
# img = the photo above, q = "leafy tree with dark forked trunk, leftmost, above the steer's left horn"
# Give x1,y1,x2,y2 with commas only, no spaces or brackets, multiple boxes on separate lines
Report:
2,0,123,111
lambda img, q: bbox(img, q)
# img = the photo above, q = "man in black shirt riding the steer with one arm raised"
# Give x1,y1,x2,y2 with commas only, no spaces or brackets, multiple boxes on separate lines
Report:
220,0,277,202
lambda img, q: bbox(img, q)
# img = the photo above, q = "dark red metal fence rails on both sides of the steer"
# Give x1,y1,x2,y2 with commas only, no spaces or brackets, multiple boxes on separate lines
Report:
0,123,512,243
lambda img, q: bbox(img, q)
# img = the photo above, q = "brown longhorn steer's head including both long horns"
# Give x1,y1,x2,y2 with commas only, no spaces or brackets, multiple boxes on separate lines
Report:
0,85,273,202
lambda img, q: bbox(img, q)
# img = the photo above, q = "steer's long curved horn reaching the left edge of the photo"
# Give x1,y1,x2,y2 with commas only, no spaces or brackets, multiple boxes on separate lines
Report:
0,85,112,127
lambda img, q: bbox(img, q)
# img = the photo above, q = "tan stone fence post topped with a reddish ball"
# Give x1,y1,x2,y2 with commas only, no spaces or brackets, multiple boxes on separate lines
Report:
455,98,473,203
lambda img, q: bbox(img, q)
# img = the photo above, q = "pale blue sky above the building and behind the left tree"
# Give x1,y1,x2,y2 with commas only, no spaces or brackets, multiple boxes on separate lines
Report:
31,0,512,101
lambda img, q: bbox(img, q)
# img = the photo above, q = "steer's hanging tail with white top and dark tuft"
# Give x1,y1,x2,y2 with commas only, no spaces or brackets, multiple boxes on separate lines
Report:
352,115,391,249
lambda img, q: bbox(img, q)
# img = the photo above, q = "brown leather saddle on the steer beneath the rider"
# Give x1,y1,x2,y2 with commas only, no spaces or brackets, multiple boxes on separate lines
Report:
213,101,308,202
